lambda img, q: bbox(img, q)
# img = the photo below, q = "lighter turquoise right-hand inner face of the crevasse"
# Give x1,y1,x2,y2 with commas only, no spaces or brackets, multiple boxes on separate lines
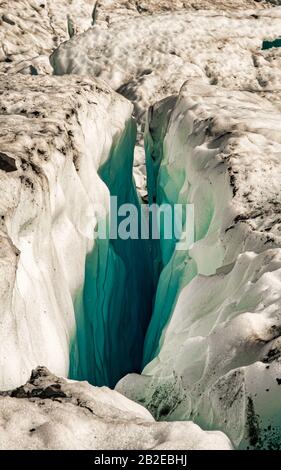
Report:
143,96,214,367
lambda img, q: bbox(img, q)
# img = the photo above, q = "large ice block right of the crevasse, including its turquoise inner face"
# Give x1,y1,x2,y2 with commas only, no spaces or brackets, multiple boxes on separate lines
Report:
117,79,281,448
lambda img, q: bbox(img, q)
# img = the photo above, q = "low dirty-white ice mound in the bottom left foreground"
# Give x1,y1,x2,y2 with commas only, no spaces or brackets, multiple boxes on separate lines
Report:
0,367,232,450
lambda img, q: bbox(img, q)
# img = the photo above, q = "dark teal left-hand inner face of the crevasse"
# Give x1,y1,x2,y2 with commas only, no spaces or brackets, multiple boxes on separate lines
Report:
69,116,155,387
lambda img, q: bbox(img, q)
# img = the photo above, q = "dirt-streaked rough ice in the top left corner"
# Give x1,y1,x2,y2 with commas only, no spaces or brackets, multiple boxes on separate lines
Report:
0,0,95,74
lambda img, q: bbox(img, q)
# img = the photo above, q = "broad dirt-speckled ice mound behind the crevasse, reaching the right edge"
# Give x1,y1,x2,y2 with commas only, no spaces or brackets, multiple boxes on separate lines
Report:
51,2,281,125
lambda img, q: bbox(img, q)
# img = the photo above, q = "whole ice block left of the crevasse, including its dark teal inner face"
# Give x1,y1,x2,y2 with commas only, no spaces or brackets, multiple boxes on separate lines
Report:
0,75,149,390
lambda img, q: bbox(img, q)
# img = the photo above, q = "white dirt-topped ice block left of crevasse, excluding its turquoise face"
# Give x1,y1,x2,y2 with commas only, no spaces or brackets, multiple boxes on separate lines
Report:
0,75,132,390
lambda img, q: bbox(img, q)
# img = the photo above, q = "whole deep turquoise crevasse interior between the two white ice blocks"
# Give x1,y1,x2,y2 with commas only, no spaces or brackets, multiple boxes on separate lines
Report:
69,97,195,387
